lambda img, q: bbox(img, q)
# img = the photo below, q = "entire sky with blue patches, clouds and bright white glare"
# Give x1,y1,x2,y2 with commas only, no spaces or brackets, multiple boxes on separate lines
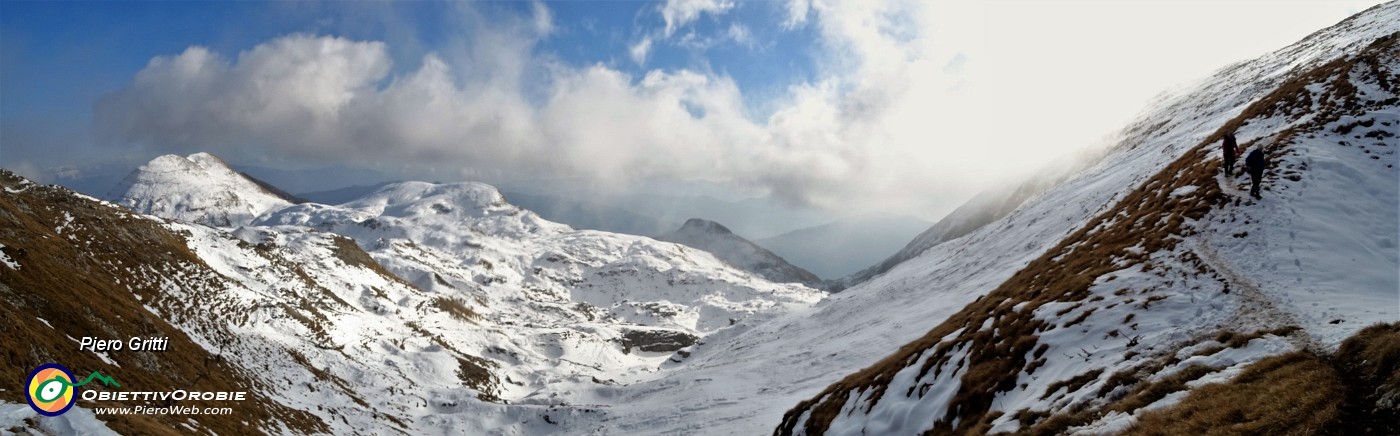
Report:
0,0,1376,219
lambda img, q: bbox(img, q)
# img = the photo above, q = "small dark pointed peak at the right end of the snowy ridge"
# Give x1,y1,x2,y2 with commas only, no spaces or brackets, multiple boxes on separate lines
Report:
657,219,822,286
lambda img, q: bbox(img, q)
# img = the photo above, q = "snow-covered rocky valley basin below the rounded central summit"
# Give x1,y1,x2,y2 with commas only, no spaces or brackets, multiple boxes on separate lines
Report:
230,182,822,429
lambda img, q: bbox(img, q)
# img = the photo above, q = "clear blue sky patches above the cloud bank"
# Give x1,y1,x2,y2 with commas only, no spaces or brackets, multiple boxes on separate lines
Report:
0,1,816,159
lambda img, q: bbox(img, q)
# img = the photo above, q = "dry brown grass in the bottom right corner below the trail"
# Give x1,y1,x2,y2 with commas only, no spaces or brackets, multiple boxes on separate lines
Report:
1047,322,1400,435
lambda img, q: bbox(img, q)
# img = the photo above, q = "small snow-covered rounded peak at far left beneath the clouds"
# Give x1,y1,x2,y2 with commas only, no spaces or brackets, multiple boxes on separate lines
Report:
112,153,290,227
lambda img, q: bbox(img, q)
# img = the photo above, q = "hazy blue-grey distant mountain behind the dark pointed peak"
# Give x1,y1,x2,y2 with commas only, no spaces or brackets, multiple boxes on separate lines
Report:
753,213,928,279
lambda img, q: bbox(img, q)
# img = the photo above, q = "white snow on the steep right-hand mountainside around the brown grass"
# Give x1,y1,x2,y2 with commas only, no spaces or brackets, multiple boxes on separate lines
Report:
532,3,1397,433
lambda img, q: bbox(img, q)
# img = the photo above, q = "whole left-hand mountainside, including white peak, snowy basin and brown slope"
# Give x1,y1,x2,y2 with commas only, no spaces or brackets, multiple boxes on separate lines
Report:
0,156,823,433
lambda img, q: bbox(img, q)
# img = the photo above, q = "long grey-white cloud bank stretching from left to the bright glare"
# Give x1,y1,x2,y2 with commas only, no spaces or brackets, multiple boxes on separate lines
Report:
97,4,1008,214
